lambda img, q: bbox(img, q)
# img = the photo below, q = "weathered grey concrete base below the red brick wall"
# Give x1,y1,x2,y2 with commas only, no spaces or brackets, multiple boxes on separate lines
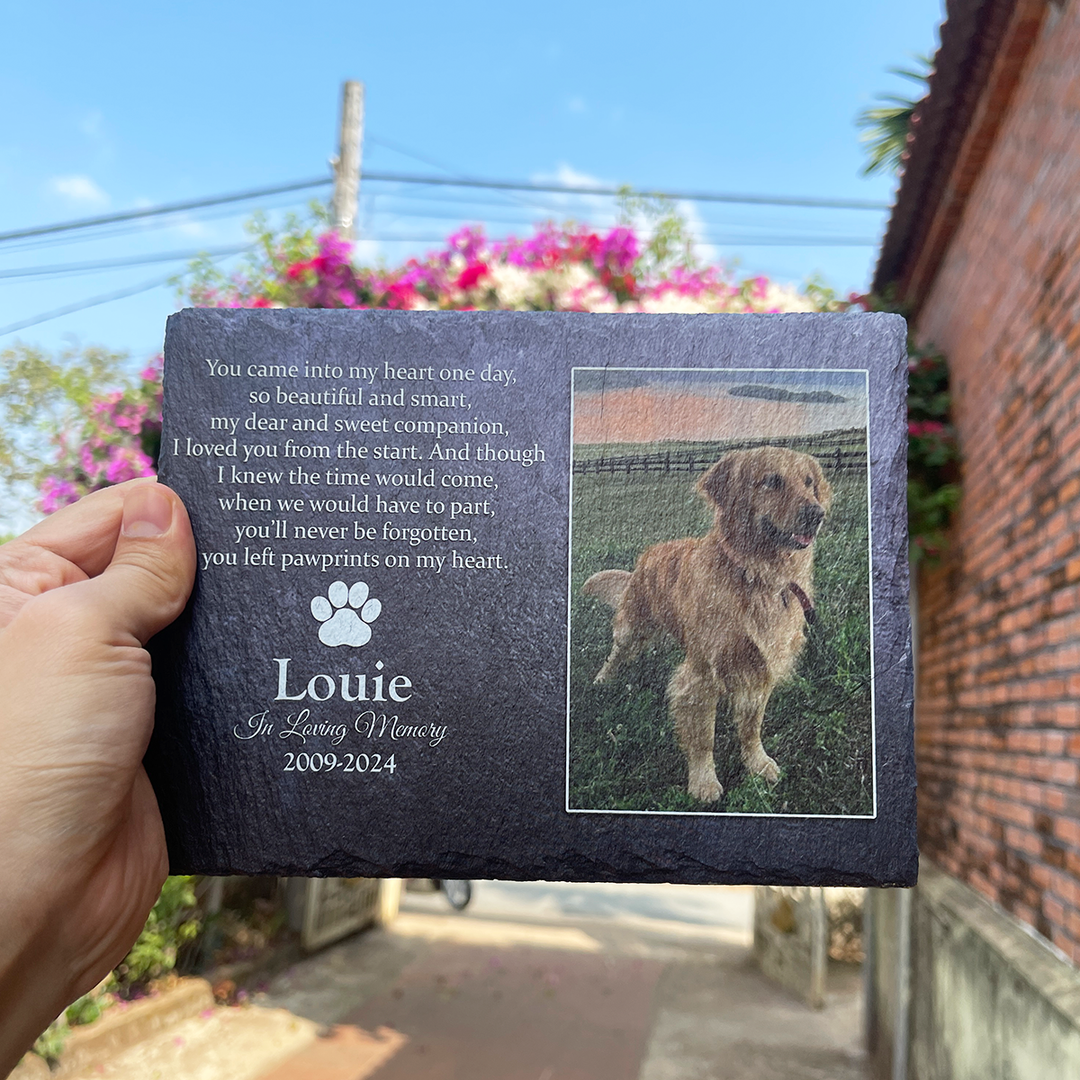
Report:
868,862,1080,1080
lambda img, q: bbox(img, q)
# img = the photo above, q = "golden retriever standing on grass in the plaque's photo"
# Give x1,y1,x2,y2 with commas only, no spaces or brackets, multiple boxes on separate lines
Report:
582,446,832,802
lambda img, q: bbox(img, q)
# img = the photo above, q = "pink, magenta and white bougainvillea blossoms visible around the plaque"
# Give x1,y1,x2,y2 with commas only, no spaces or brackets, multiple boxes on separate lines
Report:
39,221,820,513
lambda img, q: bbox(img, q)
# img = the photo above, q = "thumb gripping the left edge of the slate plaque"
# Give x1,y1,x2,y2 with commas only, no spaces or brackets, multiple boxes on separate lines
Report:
83,484,195,645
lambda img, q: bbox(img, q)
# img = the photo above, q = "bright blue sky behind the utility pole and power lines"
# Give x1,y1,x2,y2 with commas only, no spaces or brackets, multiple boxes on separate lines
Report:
0,0,941,357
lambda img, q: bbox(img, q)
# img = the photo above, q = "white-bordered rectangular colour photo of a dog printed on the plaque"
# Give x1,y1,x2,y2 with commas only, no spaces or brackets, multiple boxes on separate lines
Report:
567,368,874,816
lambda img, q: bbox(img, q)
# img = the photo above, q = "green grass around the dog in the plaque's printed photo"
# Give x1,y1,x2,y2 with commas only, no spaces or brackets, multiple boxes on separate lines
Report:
568,444,874,815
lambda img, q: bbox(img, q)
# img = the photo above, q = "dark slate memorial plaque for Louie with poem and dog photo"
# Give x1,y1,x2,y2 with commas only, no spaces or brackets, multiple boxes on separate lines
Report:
147,310,917,886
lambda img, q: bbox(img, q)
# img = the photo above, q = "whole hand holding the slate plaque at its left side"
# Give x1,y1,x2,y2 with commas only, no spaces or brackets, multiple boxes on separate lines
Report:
0,480,195,1076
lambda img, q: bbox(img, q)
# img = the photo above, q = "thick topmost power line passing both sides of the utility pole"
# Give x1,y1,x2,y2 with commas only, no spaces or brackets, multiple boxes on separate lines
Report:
0,172,889,243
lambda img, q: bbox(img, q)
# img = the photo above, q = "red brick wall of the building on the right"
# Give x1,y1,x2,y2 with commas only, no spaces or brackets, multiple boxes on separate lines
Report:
916,0,1080,962
